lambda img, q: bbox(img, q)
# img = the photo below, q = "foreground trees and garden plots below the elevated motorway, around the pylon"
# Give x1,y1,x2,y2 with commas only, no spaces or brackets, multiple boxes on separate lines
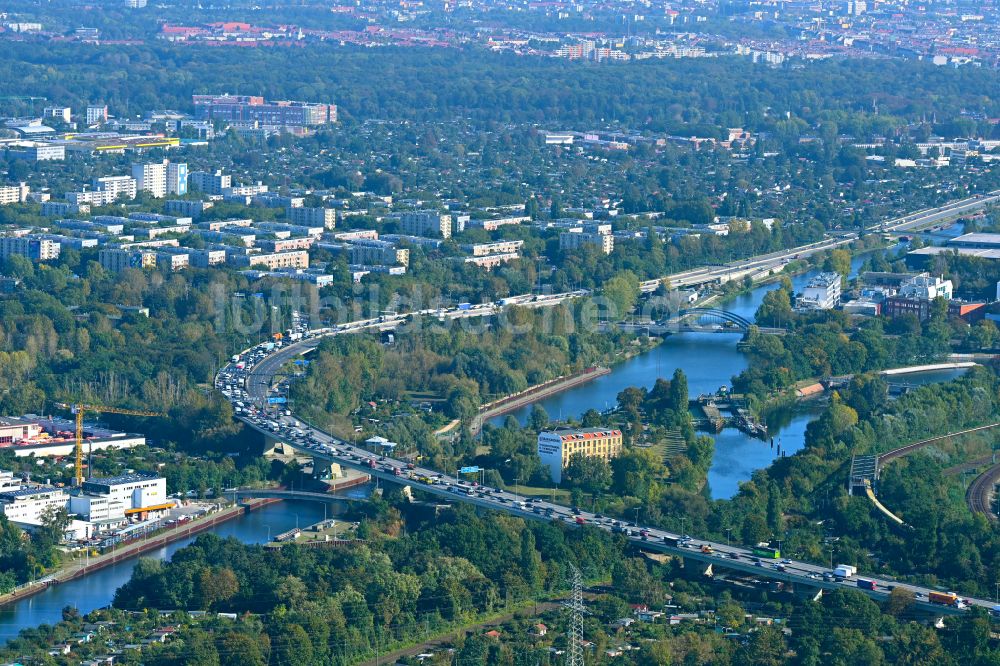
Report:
0,498,998,666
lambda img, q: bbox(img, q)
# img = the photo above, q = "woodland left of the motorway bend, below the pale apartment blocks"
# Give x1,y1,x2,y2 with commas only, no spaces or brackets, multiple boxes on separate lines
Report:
0,250,266,450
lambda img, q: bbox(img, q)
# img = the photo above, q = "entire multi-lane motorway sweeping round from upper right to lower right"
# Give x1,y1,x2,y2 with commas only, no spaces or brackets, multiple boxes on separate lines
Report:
216,192,1000,616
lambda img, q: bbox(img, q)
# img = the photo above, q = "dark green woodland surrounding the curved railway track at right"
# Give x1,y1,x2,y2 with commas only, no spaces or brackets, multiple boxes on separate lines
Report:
720,368,1000,597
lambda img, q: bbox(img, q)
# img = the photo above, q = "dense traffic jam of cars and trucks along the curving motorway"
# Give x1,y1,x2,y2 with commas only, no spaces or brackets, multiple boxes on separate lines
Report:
215,294,1000,619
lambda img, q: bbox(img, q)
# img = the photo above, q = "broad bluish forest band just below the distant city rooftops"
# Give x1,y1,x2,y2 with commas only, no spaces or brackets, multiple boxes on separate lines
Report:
0,41,1000,138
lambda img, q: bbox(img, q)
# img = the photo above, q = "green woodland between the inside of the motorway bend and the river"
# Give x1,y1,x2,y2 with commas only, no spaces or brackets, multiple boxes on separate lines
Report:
291,304,652,454
